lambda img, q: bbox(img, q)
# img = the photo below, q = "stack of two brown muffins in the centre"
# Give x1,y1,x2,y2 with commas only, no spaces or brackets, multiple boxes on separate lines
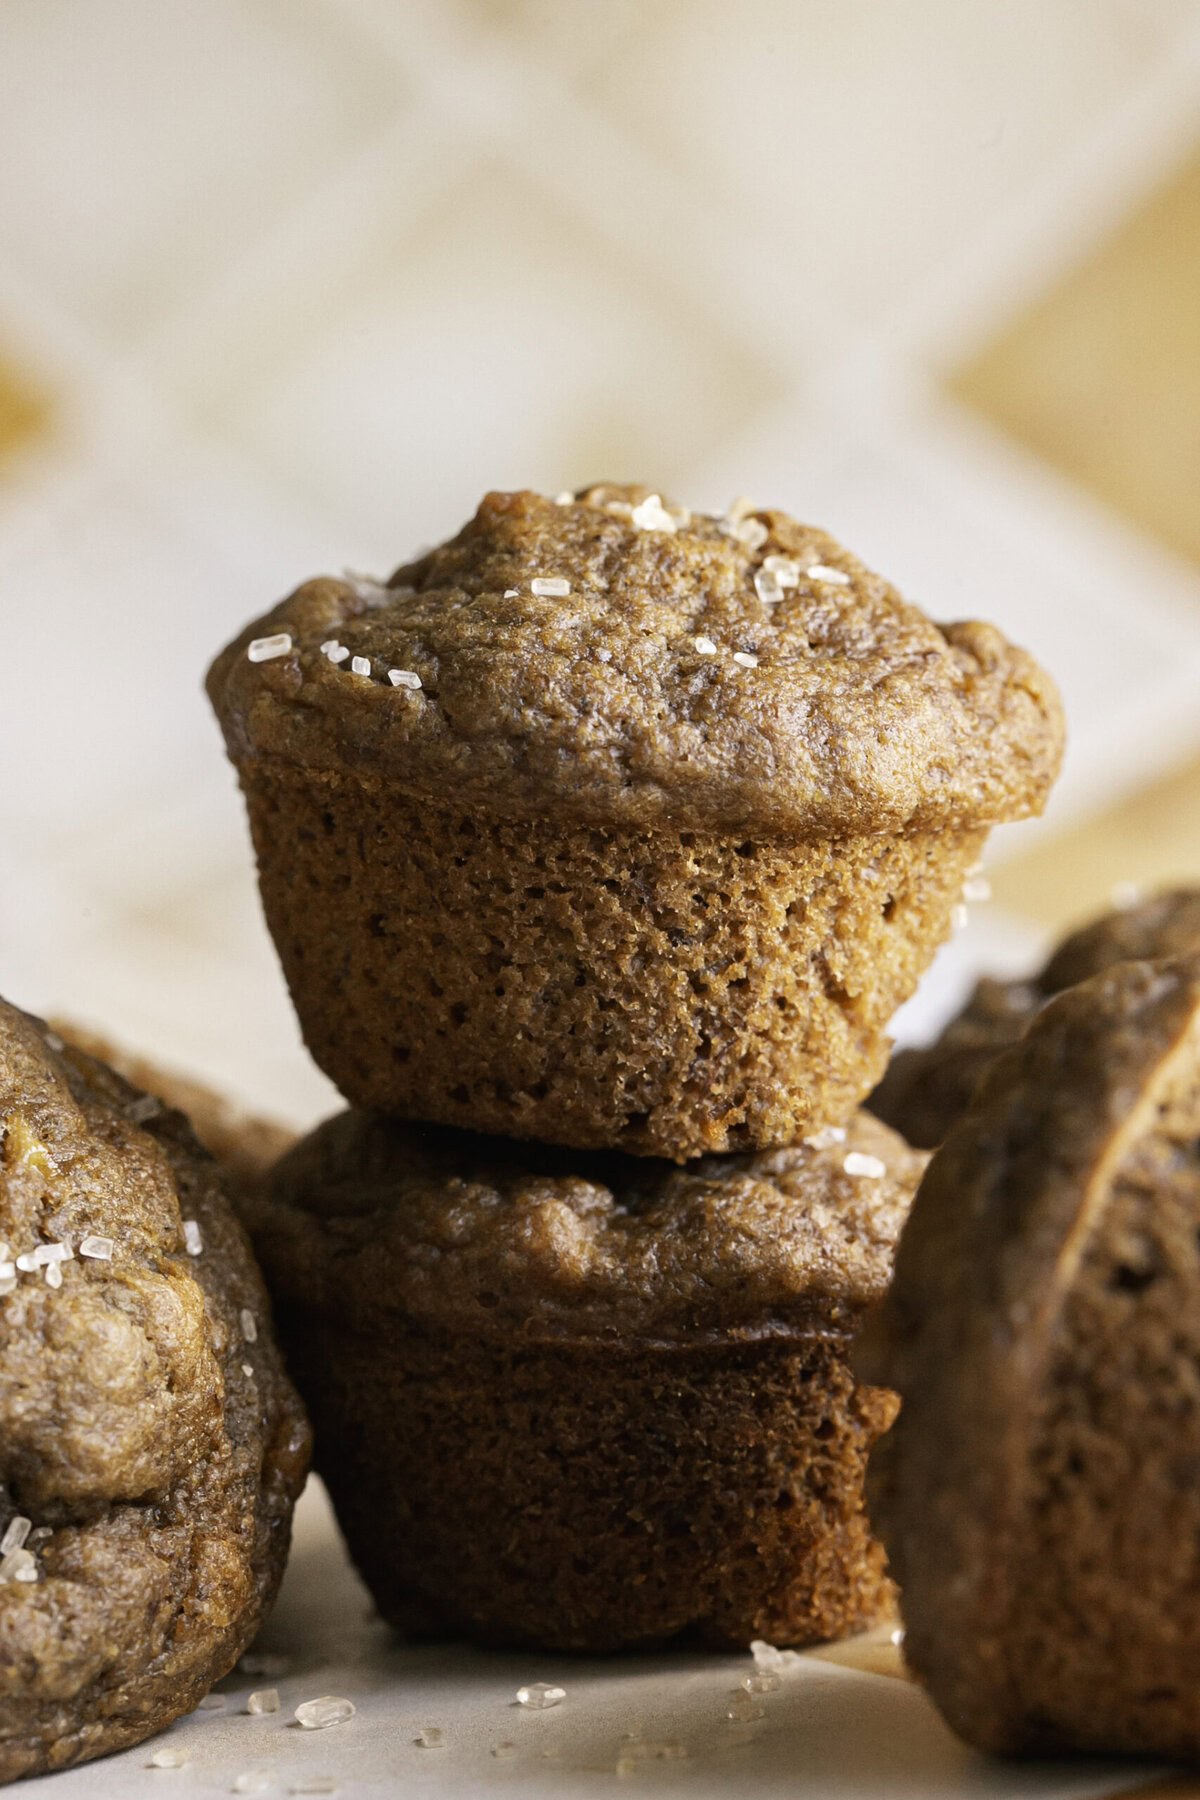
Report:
209,488,1061,1649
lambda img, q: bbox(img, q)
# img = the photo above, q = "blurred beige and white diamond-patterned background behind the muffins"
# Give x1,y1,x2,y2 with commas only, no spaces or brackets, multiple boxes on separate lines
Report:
0,0,1200,1118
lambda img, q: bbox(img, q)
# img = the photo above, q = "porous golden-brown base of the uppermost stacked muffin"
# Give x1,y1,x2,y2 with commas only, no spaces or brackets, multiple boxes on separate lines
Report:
241,761,986,1161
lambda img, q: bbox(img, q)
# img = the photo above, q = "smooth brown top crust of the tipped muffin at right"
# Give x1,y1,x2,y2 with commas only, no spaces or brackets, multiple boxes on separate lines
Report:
856,956,1200,1755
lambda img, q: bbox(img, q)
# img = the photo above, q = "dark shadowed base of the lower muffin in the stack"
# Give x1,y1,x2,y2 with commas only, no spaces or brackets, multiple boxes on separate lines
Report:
284,1319,896,1651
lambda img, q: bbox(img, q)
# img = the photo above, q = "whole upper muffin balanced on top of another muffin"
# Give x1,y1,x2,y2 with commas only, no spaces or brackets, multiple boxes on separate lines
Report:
209,488,1061,1161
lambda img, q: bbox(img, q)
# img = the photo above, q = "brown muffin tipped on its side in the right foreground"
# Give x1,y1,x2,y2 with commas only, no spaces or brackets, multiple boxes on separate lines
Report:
856,956,1200,1759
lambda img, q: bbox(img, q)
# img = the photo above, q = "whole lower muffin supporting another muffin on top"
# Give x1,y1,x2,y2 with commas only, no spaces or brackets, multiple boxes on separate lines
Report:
245,1112,925,1651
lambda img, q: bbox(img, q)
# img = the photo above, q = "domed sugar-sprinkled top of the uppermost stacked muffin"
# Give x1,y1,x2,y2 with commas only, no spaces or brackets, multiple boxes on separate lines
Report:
209,486,1063,837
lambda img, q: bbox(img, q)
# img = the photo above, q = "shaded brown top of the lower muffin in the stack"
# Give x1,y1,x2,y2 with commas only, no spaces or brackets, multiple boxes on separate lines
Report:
246,1112,927,1345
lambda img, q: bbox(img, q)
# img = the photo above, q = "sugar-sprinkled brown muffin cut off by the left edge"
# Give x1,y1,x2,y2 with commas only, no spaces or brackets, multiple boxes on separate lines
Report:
0,1003,309,1780
